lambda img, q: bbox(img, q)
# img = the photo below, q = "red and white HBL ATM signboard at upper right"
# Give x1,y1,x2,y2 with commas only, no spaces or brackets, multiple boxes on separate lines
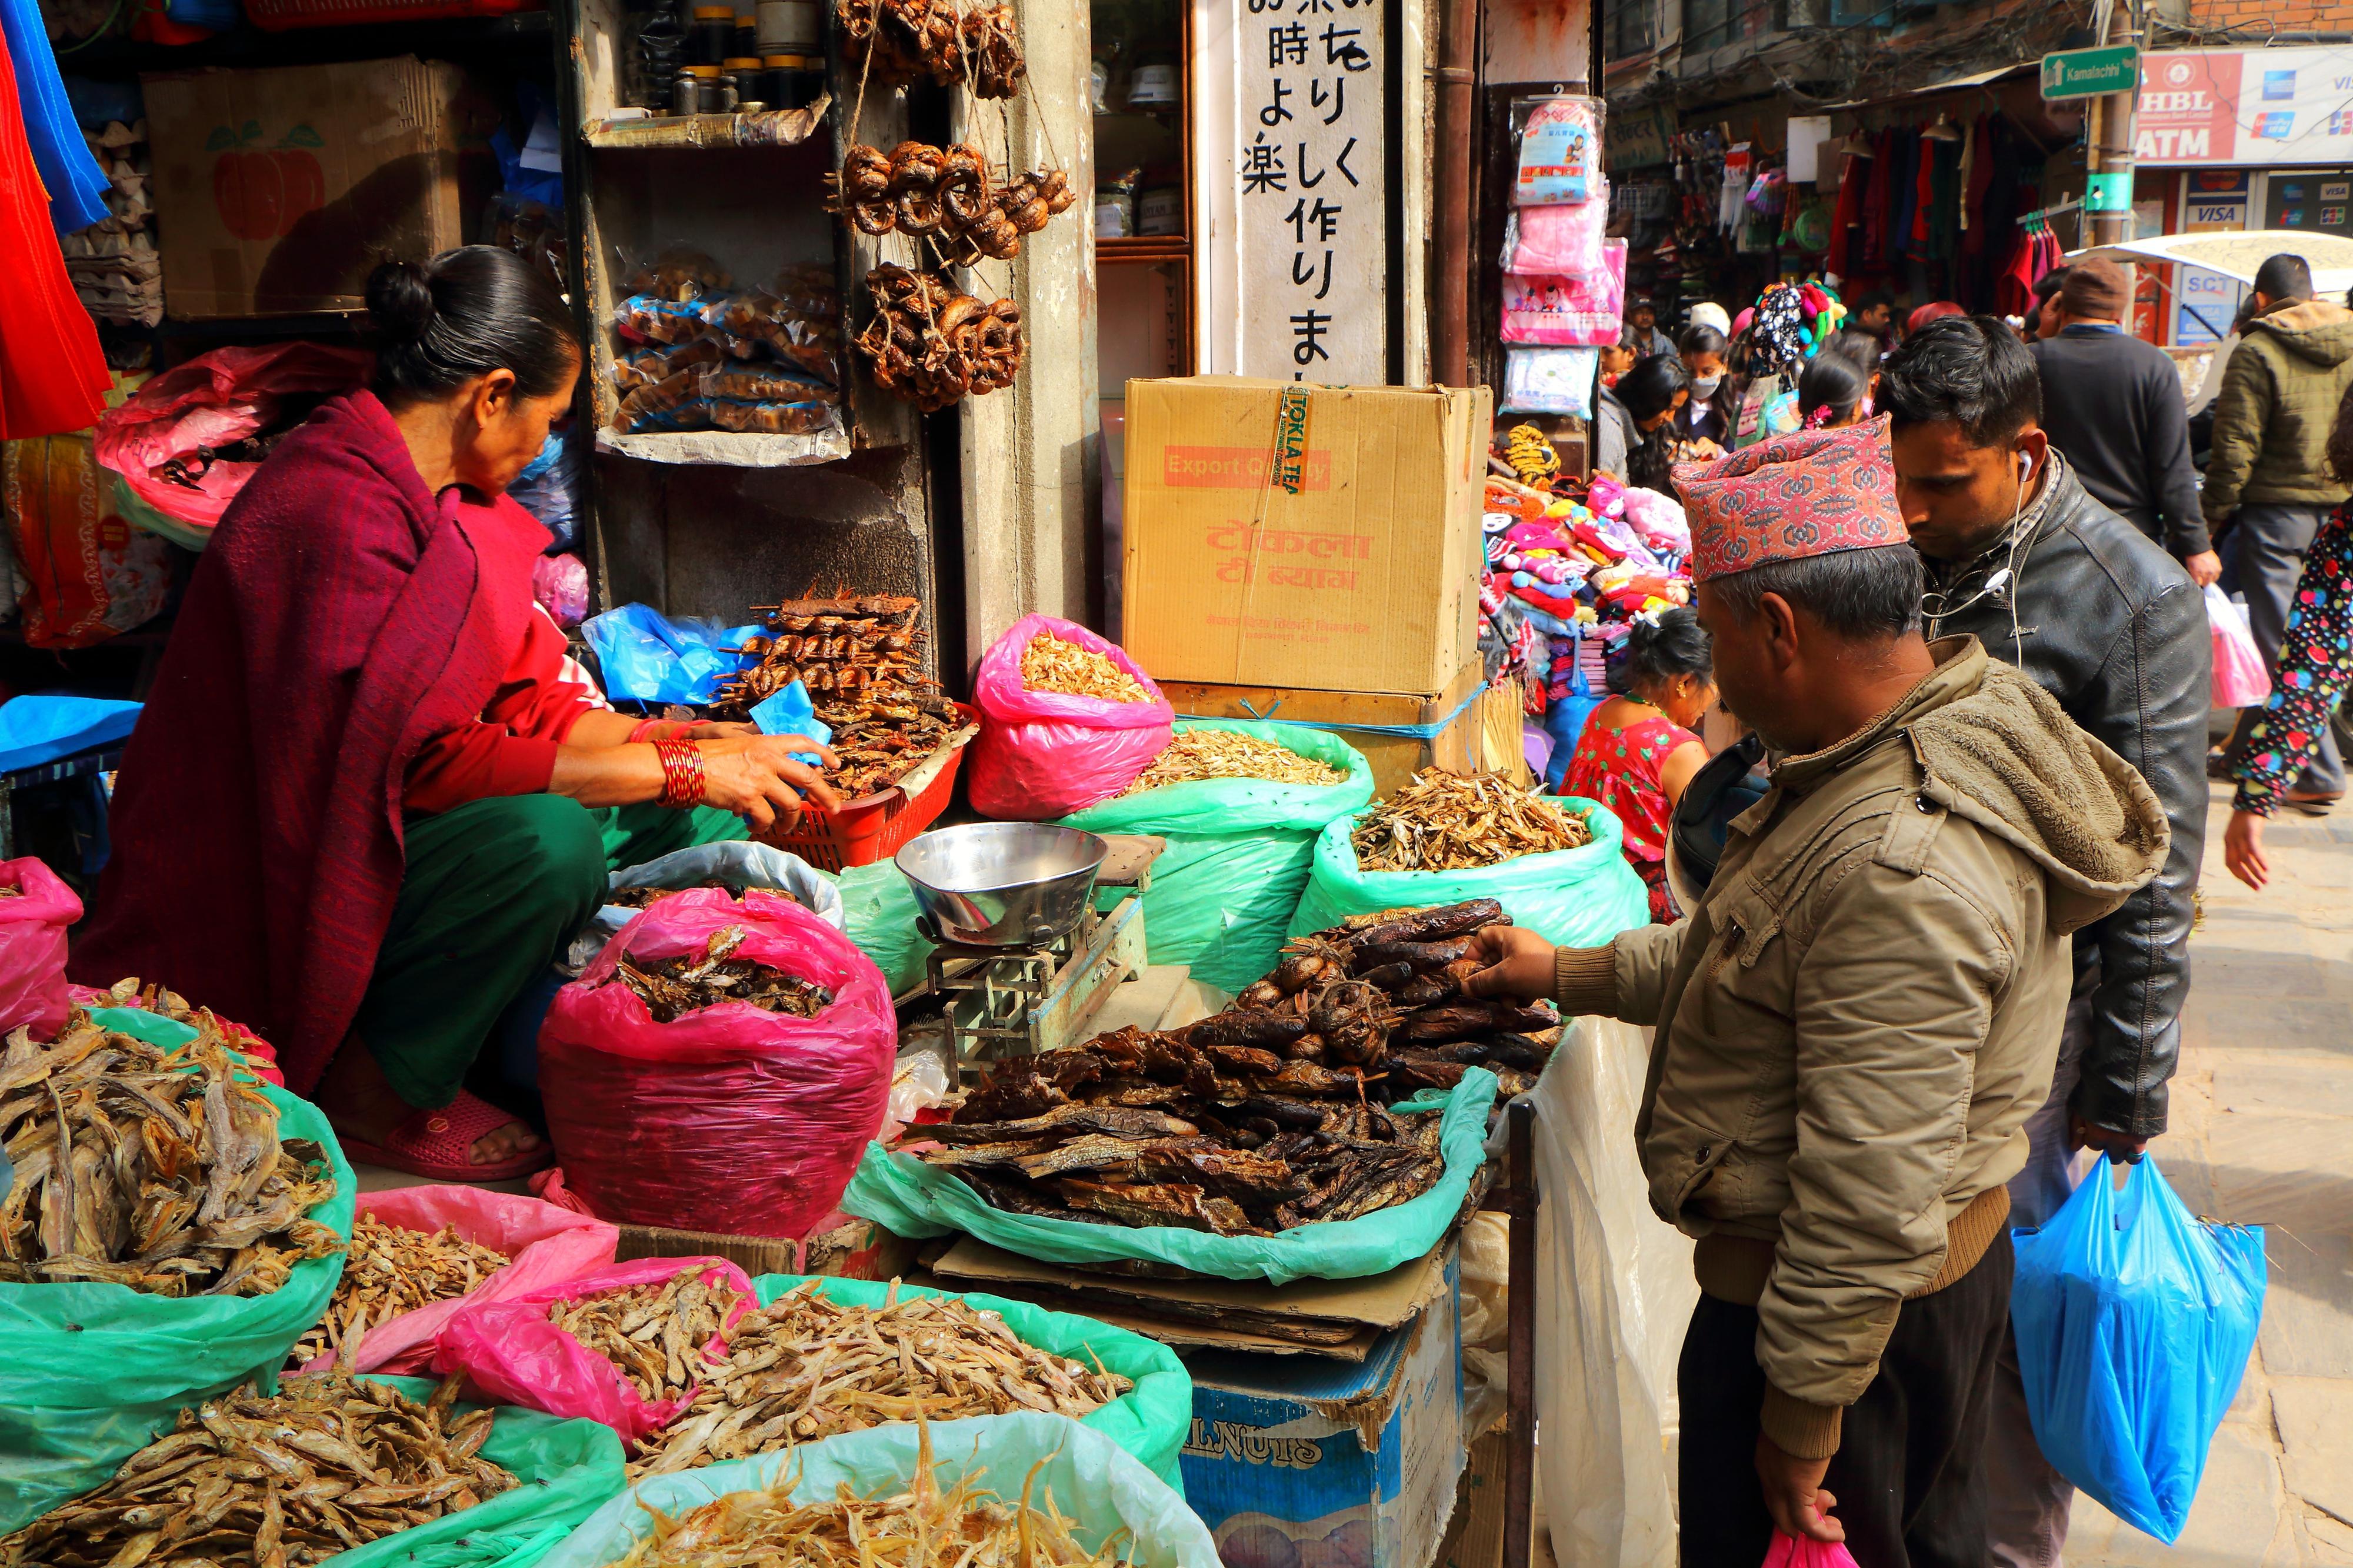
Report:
2132,45,2353,169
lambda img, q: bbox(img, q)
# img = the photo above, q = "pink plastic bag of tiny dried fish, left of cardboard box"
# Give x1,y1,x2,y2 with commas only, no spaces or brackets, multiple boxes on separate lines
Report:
965,612,1172,822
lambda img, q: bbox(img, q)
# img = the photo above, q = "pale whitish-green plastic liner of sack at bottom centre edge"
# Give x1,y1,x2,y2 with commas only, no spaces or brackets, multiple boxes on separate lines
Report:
539,1410,1221,1568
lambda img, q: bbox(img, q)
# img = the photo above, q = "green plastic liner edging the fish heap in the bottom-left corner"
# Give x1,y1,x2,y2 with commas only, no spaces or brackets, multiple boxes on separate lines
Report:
332,1375,628,1568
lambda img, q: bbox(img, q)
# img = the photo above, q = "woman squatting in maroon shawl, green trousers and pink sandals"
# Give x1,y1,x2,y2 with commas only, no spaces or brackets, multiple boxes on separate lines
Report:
71,245,838,1180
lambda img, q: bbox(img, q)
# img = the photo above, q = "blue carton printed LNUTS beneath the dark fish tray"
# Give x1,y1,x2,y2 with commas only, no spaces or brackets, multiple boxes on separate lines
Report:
1179,1246,1464,1568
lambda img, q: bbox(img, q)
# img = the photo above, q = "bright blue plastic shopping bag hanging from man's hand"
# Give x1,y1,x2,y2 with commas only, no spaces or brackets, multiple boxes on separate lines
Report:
2009,1158,2264,1544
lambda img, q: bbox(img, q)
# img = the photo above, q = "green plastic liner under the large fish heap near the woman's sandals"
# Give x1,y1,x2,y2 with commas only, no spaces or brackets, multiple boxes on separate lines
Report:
0,1073,360,1535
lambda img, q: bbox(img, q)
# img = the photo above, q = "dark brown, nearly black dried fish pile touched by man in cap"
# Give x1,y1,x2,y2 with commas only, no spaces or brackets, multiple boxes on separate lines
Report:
920,899,1560,1236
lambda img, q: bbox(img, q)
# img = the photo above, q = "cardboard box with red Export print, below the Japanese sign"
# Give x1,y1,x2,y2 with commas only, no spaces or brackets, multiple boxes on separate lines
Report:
1120,376,1494,697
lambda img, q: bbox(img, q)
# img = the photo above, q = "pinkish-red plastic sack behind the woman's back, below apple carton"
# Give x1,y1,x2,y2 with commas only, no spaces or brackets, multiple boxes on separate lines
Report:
96,339,376,530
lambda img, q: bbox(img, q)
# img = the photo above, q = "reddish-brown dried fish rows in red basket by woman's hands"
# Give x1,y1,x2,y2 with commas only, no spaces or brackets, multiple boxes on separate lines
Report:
713,593,965,800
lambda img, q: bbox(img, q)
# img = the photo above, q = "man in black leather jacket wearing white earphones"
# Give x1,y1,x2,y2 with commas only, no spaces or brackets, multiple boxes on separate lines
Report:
1880,315,2214,1568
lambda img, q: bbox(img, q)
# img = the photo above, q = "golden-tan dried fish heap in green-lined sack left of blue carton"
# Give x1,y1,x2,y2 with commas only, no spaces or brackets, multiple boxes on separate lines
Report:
628,1281,1134,1476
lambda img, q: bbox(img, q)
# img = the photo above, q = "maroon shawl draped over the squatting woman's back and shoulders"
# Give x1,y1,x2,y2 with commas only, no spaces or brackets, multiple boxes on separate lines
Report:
68,391,534,1092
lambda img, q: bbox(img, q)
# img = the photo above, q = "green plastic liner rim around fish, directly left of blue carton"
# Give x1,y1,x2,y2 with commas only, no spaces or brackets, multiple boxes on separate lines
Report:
751,1274,1193,1497
